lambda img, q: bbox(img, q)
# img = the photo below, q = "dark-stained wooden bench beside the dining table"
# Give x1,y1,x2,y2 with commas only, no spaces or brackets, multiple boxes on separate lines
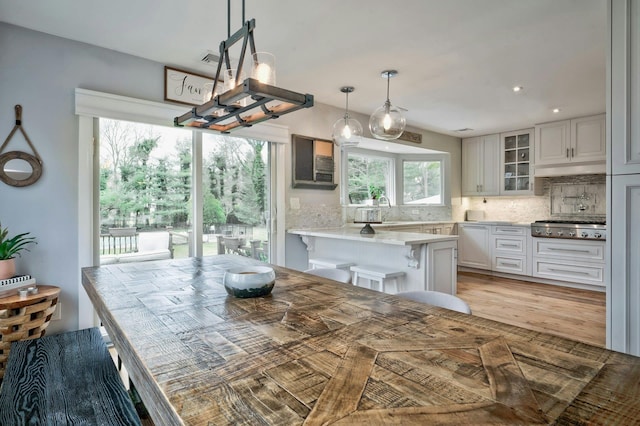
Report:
0,328,141,425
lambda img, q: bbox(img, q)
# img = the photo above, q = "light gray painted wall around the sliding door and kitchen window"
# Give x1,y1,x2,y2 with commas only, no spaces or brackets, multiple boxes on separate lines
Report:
0,23,460,333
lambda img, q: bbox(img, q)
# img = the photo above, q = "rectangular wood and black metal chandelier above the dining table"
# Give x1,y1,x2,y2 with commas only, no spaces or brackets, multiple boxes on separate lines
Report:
173,0,313,133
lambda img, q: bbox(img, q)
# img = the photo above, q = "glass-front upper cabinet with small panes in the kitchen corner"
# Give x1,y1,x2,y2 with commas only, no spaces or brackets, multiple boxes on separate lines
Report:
500,129,534,195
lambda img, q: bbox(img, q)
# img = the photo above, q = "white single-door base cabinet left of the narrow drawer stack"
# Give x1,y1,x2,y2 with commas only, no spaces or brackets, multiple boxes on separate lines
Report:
458,222,491,270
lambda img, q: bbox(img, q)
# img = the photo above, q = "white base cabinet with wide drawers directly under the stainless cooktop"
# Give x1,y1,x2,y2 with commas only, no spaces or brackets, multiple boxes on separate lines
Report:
532,238,605,286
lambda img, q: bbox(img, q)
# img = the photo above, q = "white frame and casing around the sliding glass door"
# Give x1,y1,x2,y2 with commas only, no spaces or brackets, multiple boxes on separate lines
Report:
75,88,290,328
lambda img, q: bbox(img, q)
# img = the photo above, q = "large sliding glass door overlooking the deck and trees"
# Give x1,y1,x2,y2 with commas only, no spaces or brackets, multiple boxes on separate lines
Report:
99,119,273,264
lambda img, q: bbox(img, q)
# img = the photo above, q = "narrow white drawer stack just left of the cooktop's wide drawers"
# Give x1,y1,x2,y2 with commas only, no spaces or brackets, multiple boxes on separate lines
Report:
491,225,531,275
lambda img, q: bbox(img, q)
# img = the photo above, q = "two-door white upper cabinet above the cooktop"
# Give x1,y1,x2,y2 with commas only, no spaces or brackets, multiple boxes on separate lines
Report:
534,114,607,176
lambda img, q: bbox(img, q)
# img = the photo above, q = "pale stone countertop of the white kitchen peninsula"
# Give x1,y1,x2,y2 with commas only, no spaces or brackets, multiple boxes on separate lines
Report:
287,224,458,246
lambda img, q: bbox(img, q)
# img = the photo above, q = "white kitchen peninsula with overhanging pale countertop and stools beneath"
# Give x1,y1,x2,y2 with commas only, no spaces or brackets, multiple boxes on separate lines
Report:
288,226,458,295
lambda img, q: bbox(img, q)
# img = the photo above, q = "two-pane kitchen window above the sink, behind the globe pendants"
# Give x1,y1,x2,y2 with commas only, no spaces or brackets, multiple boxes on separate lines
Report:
343,149,449,206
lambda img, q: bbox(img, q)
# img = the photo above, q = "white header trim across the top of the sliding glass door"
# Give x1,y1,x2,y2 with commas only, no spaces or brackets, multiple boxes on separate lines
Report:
75,88,291,143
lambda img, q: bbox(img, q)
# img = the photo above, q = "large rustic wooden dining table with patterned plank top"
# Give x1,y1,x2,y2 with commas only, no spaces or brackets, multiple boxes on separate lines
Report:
82,255,640,425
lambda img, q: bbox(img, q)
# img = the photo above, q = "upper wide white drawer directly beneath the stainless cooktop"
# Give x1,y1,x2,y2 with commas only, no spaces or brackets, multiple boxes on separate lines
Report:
533,238,604,263
